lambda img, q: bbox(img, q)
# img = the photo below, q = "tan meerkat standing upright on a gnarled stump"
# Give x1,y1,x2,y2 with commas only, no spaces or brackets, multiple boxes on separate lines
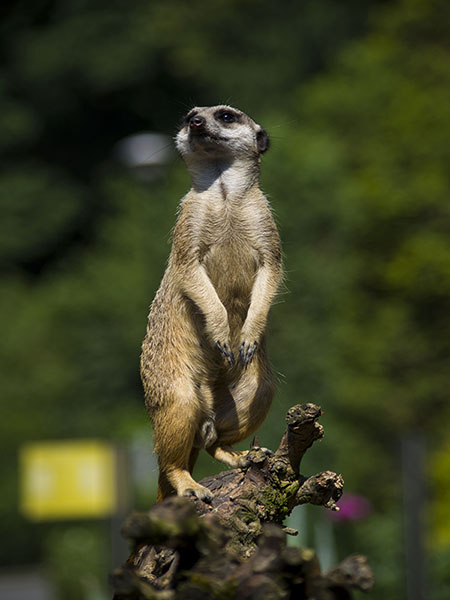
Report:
141,105,282,501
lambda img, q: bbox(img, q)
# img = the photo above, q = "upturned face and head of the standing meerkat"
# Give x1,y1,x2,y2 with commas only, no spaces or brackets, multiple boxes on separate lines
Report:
176,105,269,159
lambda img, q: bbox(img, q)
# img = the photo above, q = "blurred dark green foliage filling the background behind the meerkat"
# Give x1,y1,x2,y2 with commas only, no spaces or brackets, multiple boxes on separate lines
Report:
0,0,450,598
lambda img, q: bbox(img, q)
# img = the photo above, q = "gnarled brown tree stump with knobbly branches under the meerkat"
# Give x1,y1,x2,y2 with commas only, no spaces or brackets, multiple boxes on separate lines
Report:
112,404,373,600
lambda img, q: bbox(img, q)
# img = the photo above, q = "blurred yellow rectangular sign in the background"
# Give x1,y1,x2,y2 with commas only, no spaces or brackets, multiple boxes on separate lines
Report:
20,440,118,521
